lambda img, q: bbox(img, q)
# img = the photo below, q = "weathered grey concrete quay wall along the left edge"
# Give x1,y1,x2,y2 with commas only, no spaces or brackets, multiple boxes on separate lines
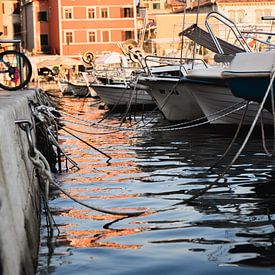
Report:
0,89,40,275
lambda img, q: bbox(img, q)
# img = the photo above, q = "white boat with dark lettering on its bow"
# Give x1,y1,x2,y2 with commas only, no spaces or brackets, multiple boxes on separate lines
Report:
137,56,206,121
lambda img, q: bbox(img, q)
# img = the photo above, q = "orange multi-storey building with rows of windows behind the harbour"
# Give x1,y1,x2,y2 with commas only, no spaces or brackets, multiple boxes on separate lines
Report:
22,0,137,56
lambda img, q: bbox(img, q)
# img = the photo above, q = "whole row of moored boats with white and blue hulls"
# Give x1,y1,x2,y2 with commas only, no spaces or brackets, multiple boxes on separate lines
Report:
59,12,275,124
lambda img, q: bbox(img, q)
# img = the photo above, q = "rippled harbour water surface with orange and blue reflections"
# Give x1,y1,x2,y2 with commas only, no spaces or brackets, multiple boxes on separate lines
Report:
37,96,275,275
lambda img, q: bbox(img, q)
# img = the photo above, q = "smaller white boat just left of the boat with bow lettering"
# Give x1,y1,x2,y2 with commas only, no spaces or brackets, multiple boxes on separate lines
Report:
90,82,155,108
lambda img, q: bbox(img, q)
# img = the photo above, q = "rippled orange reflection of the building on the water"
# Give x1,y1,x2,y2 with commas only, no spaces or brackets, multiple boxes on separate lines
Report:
55,99,150,249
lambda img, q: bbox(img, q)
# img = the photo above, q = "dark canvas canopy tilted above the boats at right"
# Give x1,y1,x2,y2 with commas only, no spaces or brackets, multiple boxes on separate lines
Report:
179,24,245,55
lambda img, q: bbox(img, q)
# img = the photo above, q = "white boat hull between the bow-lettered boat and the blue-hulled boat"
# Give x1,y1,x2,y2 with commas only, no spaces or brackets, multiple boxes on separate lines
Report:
183,67,273,124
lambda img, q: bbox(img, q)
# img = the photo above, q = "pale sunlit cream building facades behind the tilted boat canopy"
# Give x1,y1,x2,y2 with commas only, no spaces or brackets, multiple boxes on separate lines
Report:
149,0,275,55
